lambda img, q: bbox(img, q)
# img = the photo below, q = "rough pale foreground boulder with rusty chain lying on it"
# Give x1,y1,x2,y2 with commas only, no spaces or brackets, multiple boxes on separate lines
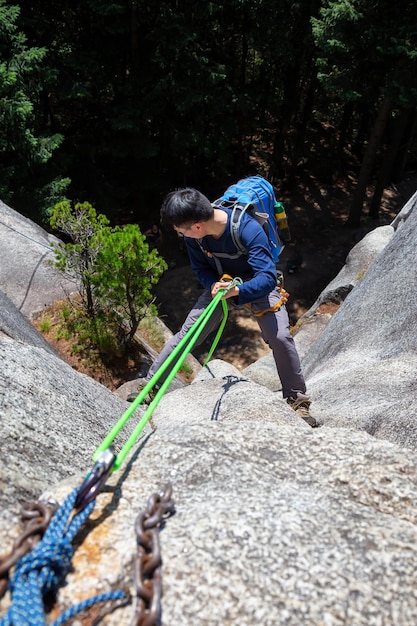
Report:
45,420,417,626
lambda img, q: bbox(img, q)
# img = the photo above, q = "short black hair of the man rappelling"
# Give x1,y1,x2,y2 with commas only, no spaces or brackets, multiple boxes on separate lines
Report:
161,187,214,227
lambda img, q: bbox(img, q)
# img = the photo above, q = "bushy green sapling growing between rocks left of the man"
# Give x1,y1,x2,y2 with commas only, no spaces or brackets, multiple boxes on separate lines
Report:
50,200,167,347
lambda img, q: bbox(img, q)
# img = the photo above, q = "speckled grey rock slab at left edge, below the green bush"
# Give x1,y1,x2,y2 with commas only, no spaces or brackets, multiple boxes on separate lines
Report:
0,337,143,512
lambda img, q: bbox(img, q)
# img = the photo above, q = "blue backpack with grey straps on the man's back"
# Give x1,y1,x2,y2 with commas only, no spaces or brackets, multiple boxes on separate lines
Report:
212,176,289,262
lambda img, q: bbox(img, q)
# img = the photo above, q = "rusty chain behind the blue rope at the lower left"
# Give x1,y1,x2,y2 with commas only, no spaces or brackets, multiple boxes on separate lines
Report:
0,500,59,599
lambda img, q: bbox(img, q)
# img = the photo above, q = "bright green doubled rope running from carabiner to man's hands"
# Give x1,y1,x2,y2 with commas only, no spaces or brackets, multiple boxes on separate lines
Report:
93,278,241,471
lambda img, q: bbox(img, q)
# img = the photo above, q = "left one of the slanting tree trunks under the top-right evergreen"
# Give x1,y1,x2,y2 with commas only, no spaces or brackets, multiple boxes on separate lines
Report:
347,96,392,228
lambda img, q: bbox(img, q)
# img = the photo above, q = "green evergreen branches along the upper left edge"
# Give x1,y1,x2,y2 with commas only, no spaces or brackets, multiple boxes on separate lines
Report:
0,0,67,217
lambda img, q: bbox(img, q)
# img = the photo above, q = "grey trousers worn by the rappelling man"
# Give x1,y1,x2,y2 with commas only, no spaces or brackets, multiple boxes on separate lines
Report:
147,289,306,398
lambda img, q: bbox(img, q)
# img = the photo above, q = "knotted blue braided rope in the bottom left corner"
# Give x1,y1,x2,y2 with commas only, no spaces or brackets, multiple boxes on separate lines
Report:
0,487,126,626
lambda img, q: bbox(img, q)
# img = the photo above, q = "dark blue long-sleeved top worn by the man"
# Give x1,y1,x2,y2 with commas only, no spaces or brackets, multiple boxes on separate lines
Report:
184,208,277,304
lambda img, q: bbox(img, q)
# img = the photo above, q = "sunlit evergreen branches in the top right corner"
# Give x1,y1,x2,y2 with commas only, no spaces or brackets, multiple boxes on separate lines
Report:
311,0,417,103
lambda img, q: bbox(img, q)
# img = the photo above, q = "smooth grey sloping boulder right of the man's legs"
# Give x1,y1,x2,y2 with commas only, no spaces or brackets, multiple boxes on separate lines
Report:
303,194,417,449
